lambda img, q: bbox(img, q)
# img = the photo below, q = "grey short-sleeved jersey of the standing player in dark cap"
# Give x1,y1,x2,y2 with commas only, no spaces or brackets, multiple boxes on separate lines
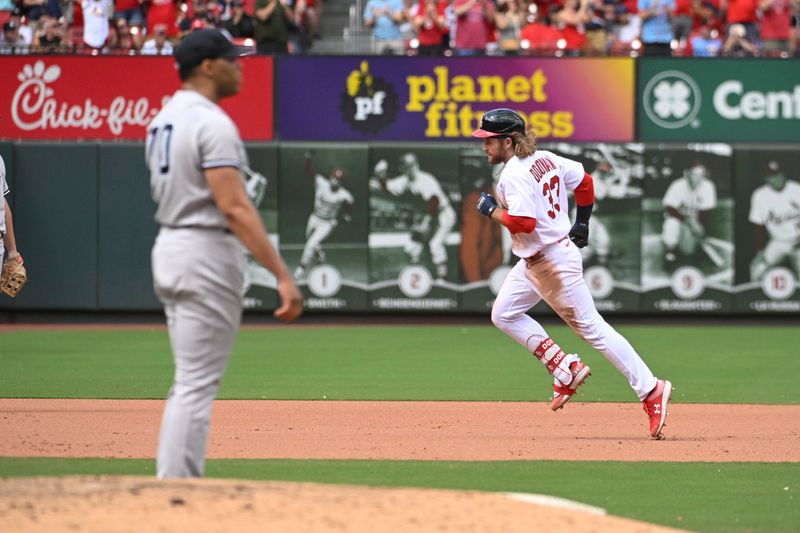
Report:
146,90,247,228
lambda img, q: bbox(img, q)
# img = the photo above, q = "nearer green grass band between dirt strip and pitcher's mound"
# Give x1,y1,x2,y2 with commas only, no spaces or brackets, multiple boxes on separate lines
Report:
0,458,800,533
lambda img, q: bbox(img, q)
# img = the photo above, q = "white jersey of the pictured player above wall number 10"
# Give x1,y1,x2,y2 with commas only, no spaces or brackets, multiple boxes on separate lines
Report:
749,181,800,242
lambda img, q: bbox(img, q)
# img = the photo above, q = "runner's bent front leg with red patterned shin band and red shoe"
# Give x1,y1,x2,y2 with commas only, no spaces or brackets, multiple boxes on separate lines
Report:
492,260,590,411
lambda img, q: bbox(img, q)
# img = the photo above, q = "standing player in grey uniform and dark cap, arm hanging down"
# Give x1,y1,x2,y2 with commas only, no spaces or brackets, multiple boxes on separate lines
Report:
146,29,303,478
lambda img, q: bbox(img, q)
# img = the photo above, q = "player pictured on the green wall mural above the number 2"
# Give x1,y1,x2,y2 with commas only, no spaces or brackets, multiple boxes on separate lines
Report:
376,152,456,279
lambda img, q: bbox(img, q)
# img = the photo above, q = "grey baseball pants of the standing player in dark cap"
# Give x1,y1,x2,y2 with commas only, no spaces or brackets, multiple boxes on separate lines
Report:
152,228,244,478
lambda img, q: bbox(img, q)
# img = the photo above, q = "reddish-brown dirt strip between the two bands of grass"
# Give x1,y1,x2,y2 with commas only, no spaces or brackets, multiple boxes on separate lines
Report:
0,399,800,462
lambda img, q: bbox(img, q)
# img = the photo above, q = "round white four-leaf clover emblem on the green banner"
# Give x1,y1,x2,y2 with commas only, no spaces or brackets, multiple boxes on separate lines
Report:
642,70,702,130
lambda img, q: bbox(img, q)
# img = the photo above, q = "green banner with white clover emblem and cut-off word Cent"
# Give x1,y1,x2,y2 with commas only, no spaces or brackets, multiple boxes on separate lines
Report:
638,58,800,142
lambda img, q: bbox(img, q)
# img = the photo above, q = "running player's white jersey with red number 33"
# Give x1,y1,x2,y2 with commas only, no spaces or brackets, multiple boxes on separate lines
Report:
495,150,585,258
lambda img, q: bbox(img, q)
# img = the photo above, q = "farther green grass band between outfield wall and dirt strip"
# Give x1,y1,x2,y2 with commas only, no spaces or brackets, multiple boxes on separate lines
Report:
0,325,800,404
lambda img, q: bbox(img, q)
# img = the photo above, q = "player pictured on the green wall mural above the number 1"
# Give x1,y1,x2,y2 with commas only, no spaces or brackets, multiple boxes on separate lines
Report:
294,153,354,279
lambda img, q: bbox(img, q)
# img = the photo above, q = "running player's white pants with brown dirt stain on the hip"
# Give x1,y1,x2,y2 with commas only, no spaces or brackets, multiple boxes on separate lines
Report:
492,237,657,400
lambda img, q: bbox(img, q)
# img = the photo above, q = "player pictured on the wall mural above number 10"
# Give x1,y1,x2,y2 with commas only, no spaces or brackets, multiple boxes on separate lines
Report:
748,161,800,280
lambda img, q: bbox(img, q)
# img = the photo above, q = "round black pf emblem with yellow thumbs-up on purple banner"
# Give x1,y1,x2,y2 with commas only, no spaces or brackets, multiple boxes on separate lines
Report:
339,60,399,134
